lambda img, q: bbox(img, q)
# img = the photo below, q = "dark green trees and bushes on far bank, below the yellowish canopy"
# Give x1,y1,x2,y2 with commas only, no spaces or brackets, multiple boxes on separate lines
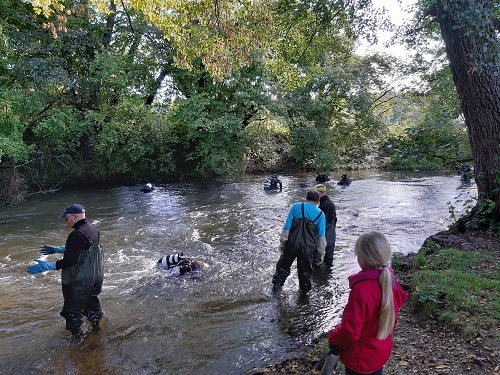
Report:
0,0,471,204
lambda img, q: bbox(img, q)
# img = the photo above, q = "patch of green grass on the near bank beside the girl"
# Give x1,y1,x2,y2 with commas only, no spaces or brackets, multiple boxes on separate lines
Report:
407,249,500,339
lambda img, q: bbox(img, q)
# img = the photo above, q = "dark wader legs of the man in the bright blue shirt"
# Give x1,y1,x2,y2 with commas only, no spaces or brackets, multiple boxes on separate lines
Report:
273,248,312,292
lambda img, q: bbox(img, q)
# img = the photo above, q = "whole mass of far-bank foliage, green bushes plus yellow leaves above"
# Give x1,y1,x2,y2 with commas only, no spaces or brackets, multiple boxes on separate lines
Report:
0,0,484,209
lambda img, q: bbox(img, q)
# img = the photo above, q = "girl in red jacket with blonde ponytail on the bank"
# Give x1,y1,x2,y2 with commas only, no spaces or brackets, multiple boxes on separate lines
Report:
328,232,408,375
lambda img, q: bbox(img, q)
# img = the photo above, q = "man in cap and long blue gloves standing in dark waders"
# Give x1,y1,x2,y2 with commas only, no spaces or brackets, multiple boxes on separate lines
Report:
28,204,104,338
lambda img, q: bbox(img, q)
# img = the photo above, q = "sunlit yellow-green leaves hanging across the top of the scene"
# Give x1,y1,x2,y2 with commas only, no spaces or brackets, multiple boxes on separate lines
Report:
29,0,386,80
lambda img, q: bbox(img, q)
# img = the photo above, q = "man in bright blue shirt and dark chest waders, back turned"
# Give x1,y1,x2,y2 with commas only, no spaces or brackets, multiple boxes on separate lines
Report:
273,190,326,295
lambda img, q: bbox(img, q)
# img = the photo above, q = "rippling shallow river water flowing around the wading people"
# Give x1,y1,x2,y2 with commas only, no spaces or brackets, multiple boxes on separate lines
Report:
0,171,476,375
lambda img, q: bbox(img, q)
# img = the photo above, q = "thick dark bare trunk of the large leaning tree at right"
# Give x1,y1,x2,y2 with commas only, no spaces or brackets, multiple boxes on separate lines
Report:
434,0,500,221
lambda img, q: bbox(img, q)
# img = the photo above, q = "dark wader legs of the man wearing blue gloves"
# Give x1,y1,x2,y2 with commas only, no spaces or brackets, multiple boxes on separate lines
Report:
61,280,102,333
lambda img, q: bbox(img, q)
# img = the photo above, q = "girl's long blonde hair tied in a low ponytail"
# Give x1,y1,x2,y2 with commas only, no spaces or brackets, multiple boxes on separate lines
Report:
354,232,396,340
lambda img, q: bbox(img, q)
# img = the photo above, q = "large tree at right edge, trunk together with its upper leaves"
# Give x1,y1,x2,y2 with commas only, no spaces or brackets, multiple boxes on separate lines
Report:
407,0,500,222
